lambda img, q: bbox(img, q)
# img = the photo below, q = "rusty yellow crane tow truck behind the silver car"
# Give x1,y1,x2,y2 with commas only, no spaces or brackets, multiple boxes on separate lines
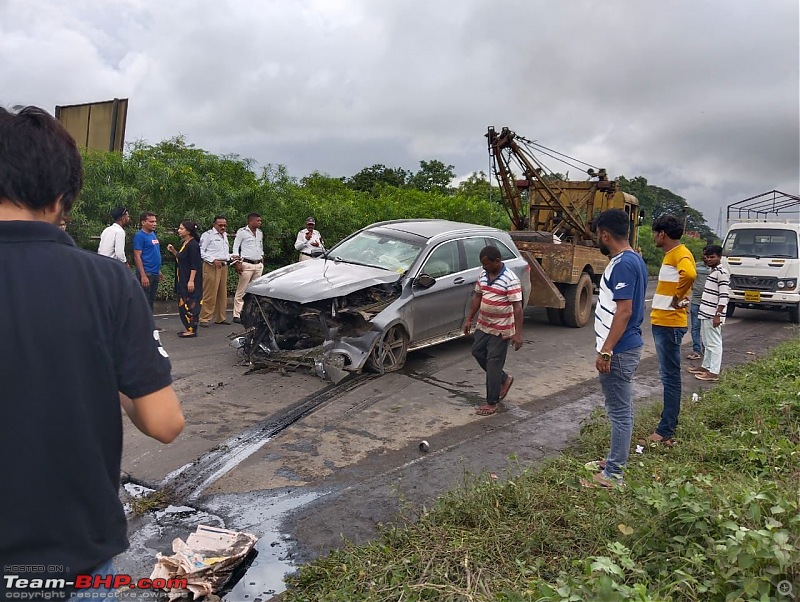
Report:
486,127,640,328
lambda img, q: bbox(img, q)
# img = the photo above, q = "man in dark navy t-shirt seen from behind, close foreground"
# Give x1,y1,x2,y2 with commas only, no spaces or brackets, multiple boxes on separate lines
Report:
0,107,184,597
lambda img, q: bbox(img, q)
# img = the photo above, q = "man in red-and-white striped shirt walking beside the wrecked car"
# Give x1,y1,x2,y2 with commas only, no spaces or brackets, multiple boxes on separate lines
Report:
464,245,522,416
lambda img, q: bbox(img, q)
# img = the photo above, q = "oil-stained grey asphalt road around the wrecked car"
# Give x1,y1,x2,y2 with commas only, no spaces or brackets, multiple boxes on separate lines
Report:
119,286,800,602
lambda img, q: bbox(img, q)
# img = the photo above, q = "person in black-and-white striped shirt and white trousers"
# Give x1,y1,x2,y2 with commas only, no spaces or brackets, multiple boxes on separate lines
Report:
689,245,730,382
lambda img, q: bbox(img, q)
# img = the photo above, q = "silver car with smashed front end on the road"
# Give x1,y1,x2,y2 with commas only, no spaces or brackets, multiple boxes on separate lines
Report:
234,220,531,383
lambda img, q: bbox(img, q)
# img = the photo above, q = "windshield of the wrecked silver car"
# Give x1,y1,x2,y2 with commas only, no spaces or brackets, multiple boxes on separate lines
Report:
328,230,423,274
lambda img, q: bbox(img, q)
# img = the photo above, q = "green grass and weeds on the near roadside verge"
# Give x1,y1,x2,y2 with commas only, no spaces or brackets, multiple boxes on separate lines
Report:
283,341,800,602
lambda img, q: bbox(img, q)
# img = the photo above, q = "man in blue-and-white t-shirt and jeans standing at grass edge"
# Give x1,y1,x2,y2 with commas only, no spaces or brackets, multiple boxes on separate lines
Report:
581,209,647,487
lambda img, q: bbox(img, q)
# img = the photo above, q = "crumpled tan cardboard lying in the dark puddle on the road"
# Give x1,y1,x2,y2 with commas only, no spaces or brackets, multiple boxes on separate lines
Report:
150,525,258,600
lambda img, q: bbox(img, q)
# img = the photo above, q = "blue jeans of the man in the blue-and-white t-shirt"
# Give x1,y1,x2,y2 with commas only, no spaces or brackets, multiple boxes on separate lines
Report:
599,347,642,479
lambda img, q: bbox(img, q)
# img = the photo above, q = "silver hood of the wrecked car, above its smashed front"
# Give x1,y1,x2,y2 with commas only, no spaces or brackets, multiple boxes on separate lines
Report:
247,259,402,303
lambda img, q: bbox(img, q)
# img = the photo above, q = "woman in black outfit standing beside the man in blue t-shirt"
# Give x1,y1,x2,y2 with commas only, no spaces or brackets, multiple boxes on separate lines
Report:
167,220,203,339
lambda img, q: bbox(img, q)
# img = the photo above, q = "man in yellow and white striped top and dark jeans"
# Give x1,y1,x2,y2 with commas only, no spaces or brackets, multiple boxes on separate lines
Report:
649,215,697,445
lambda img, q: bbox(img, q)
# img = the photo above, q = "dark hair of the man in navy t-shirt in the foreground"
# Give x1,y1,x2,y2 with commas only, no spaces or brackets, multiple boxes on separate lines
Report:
0,107,83,212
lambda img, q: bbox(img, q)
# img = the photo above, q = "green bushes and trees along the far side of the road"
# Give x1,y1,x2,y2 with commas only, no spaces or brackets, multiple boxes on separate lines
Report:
67,136,713,299
